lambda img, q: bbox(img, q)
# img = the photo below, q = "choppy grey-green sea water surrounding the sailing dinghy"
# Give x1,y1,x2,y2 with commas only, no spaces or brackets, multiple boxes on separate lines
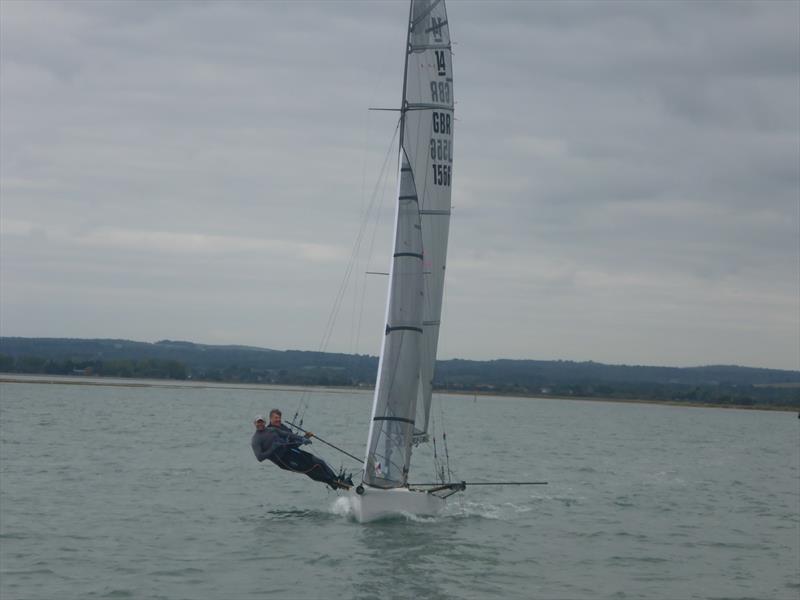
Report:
0,380,800,600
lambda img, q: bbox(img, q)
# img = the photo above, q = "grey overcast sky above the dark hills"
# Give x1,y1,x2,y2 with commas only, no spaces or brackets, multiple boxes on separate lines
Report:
0,0,800,369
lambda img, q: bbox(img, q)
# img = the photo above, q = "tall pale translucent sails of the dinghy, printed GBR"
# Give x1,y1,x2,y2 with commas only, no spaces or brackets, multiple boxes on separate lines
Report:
364,0,453,488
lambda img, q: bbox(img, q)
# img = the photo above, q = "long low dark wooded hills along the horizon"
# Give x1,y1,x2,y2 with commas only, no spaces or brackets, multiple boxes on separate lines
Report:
0,337,800,407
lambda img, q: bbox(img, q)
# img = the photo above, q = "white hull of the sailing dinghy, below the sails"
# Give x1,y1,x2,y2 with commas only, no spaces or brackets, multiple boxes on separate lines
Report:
349,486,445,523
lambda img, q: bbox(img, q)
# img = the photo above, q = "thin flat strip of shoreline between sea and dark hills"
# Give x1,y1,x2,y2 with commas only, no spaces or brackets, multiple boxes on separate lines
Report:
0,373,798,412
